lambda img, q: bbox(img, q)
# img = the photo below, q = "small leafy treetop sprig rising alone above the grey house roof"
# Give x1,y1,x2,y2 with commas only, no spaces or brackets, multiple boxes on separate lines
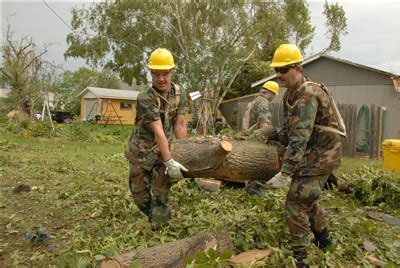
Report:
323,1,347,52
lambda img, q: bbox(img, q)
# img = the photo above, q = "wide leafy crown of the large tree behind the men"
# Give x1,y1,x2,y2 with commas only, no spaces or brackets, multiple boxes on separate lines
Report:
65,0,313,111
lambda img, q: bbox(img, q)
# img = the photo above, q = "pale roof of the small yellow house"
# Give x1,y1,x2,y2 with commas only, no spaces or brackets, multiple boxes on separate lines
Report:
77,87,139,100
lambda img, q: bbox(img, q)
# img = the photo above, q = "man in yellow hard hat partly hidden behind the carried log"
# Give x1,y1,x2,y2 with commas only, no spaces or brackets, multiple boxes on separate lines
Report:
242,81,279,196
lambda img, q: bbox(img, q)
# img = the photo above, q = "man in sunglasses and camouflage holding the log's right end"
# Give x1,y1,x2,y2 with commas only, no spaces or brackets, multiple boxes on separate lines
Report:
270,44,346,267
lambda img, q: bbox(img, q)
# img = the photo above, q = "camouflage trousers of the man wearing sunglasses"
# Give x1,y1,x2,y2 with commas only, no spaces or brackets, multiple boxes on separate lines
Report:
285,174,329,251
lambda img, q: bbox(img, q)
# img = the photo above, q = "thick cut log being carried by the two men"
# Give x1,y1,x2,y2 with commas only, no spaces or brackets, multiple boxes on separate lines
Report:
171,137,284,181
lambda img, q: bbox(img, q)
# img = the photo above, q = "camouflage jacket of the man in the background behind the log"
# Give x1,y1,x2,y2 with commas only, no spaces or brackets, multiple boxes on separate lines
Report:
243,95,272,130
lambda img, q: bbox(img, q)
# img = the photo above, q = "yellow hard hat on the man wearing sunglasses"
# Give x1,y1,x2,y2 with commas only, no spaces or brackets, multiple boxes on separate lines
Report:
269,44,303,67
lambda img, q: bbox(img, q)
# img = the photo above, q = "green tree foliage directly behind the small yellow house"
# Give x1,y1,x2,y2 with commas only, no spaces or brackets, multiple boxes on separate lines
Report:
56,67,120,115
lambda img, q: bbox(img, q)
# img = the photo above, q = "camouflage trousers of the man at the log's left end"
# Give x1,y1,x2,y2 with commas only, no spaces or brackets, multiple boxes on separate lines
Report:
129,161,171,225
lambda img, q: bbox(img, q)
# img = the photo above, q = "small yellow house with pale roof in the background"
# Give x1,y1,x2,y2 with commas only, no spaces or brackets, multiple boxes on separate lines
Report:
78,87,139,125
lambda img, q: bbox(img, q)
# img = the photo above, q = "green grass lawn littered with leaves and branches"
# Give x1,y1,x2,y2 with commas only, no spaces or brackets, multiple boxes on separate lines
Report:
0,126,400,267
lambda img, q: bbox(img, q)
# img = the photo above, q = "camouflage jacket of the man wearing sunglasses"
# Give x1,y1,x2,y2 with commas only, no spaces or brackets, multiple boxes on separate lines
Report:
280,77,342,176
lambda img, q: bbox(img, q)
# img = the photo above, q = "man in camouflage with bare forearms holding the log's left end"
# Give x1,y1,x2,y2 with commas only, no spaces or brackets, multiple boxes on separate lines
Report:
125,48,187,227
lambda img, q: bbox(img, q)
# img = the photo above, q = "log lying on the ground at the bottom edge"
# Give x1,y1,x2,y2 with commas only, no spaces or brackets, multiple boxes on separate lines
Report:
101,233,233,268
